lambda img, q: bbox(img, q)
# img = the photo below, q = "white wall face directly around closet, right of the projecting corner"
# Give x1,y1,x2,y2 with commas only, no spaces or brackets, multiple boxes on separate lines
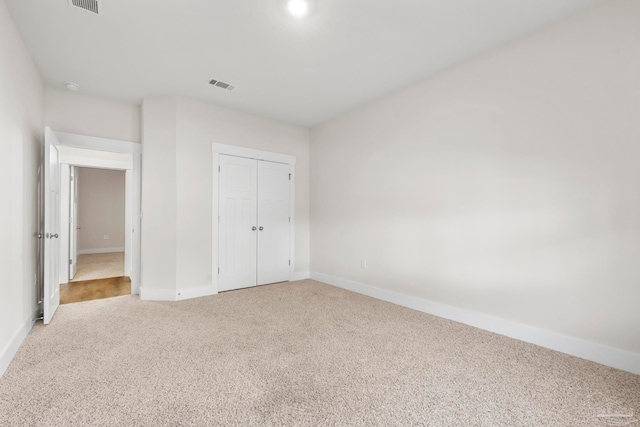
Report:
176,97,309,289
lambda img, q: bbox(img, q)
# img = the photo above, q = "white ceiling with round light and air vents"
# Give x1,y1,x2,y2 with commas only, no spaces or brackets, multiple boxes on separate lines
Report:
5,0,600,127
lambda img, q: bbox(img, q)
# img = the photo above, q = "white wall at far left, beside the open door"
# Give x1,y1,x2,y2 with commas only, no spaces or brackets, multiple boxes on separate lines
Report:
0,1,44,375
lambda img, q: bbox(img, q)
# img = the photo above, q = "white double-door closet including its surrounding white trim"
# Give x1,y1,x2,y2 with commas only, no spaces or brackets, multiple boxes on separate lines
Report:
212,144,295,292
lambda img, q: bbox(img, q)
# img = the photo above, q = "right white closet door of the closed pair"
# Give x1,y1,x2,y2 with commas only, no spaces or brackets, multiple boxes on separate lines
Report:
258,161,290,285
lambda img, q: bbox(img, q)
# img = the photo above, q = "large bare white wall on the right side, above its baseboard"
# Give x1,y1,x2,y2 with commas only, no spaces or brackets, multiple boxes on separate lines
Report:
311,0,640,358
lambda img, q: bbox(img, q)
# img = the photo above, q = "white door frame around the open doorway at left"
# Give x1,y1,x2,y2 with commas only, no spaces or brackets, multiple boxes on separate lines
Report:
54,132,142,294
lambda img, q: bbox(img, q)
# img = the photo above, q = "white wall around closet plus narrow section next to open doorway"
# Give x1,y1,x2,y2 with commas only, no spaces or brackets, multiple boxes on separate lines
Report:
142,97,309,298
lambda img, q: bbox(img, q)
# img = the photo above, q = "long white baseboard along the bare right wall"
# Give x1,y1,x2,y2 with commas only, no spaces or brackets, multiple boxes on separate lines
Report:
311,271,640,374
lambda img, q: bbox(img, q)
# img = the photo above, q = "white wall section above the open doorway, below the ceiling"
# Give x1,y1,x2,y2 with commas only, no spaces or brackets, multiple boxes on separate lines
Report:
44,87,142,142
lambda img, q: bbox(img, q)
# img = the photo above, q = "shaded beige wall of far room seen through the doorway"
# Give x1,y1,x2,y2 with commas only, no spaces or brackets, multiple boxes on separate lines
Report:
78,168,125,253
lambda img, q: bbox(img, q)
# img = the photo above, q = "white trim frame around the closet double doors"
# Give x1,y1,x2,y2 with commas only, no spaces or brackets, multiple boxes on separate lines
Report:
211,142,296,294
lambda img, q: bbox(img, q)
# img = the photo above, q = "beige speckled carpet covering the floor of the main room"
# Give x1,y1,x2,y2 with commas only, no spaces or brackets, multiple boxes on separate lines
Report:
0,280,640,427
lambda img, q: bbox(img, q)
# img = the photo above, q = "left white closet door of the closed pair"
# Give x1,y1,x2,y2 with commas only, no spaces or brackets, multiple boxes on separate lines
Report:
218,155,258,291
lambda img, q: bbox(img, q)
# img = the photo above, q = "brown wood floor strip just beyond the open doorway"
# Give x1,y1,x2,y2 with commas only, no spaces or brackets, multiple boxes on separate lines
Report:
60,276,131,304
